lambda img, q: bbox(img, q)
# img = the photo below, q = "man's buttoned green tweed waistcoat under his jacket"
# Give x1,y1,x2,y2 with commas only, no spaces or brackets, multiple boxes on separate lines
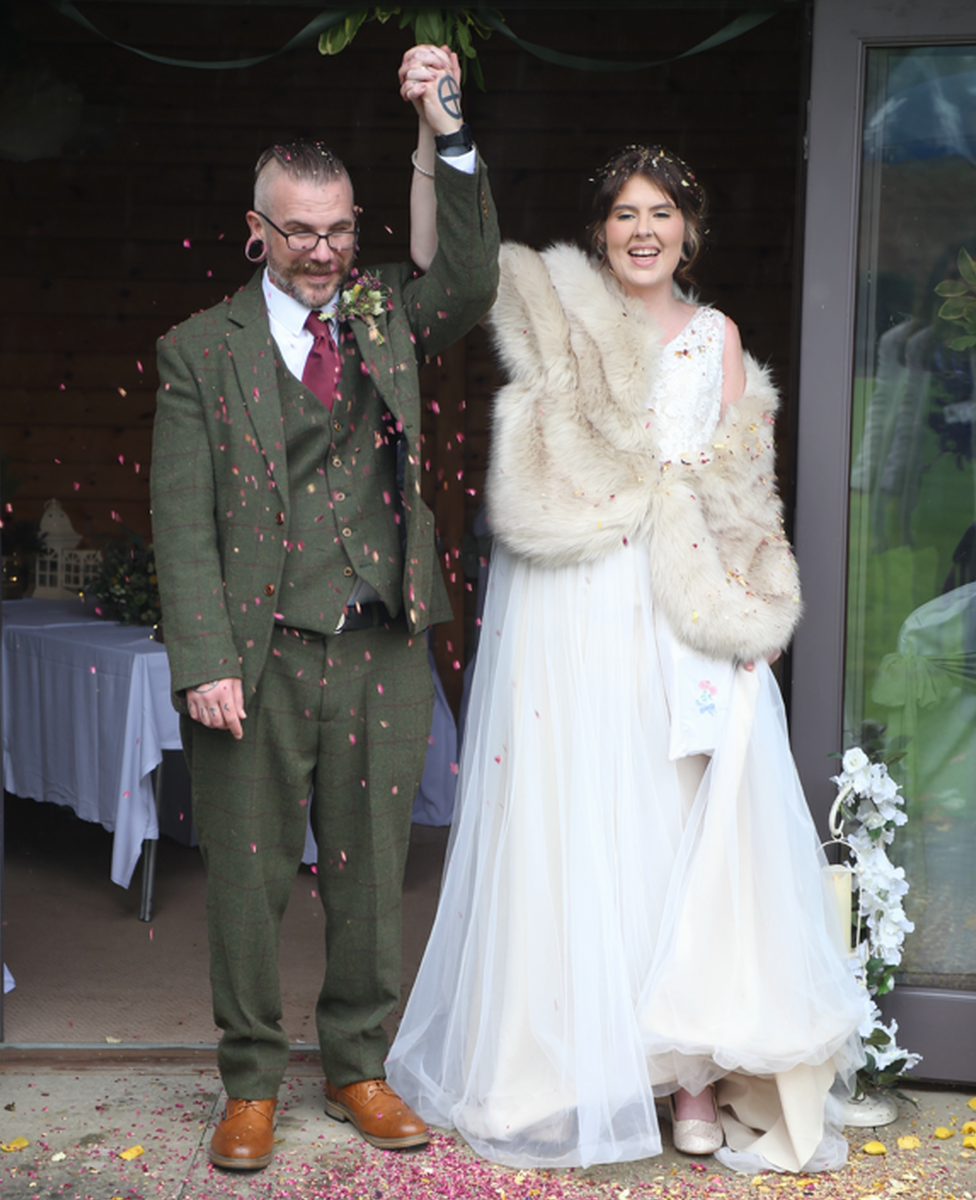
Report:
277,350,403,634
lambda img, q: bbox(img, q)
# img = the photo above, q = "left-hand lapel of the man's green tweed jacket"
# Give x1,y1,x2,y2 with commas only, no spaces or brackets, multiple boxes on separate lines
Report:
227,271,288,500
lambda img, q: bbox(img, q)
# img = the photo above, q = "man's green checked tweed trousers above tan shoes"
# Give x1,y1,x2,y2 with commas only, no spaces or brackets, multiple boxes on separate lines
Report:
182,617,433,1099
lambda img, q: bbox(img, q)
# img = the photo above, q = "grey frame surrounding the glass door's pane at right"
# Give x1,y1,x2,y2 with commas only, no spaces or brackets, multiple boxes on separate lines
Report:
791,0,976,1081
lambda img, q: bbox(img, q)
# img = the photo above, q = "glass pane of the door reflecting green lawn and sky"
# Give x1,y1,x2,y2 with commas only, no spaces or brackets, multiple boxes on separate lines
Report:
844,46,976,990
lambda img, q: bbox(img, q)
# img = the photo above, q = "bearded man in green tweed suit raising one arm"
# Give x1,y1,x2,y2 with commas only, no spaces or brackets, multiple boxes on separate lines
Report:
151,47,498,1169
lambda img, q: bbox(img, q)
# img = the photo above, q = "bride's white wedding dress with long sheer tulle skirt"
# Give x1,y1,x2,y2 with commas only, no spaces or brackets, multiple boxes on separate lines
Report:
387,308,864,1171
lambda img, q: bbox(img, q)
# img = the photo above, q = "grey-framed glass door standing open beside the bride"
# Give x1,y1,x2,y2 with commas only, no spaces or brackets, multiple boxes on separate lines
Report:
792,0,976,1080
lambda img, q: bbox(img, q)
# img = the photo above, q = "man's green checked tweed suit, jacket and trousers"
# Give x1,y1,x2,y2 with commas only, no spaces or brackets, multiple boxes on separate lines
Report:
151,160,498,1099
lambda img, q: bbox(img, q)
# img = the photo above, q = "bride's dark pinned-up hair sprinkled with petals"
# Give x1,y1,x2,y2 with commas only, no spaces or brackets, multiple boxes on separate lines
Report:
586,145,707,283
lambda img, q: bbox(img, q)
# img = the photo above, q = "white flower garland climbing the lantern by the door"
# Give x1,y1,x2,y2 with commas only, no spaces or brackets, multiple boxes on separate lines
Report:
831,746,922,1087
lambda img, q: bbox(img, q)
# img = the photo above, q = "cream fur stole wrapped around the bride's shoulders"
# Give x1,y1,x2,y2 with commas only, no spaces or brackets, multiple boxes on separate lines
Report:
487,237,801,661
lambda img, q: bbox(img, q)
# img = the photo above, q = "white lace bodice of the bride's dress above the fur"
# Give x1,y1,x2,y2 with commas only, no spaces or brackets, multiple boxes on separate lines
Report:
647,307,725,462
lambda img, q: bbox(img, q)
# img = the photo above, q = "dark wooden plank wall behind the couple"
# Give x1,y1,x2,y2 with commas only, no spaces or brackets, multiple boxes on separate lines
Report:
0,0,806,690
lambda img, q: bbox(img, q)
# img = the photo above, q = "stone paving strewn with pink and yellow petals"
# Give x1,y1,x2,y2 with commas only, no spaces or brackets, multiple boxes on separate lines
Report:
0,1048,976,1200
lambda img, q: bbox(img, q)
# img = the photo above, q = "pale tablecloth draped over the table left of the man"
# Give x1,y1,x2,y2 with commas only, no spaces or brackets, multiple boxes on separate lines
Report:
2,600,180,887
